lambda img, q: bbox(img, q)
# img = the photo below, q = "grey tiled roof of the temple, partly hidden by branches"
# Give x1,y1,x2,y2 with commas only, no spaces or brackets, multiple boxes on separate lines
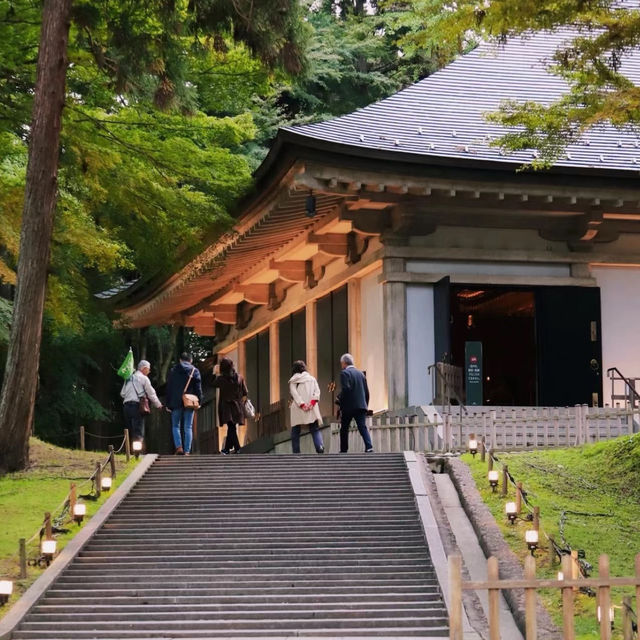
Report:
284,23,640,172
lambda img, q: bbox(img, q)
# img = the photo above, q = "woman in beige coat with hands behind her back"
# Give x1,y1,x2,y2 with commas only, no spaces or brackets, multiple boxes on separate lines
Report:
289,360,324,453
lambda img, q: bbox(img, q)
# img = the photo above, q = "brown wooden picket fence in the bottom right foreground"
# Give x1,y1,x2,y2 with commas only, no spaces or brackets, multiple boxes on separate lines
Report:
449,554,640,640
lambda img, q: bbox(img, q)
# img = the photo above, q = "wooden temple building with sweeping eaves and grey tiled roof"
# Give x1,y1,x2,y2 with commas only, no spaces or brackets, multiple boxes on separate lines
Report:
117,25,640,444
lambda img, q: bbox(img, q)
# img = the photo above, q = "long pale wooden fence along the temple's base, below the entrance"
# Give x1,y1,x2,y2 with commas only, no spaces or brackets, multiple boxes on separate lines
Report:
330,405,638,453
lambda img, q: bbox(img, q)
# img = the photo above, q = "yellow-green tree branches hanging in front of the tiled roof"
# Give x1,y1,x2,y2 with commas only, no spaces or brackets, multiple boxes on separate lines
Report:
400,0,640,168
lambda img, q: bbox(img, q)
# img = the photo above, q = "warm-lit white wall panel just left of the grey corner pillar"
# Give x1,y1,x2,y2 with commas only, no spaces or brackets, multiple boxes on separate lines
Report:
356,270,388,411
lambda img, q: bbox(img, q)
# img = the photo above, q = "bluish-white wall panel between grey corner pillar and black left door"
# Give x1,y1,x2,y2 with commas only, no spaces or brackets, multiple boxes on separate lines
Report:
407,285,435,406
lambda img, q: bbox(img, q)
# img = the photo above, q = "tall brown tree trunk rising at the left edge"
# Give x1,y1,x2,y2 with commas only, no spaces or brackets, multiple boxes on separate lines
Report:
0,0,72,472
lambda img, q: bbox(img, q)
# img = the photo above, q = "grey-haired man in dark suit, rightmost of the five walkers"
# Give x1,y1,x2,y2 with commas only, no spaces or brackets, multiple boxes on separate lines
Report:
338,353,373,453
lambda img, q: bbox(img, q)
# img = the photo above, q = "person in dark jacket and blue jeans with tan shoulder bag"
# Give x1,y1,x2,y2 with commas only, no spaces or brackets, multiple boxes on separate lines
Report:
167,353,202,455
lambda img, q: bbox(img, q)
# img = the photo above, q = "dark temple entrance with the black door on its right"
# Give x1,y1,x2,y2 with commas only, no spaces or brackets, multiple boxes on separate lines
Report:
449,285,602,406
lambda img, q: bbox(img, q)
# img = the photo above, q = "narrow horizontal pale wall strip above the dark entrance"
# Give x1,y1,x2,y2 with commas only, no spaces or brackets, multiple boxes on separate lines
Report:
407,260,571,278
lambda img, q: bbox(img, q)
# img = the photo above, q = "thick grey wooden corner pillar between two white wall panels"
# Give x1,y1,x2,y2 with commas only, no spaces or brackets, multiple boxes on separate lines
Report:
382,282,409,410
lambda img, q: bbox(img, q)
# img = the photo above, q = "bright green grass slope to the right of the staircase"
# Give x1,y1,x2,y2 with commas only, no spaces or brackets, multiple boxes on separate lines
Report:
462,434,640,640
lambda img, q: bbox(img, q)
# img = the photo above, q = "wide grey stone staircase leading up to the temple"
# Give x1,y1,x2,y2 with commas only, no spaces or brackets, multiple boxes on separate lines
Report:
12,454,448,640
